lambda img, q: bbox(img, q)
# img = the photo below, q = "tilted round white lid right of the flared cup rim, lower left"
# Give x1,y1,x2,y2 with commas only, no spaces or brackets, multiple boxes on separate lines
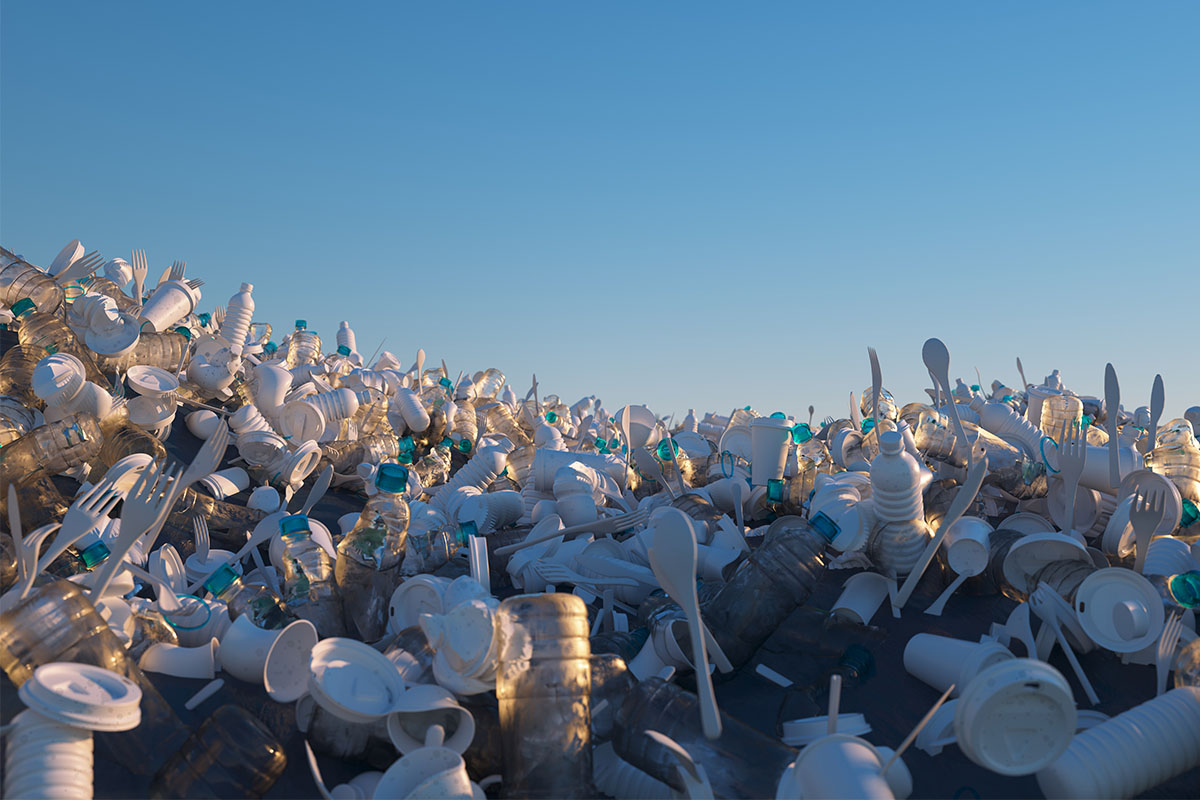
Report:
308,637,404,722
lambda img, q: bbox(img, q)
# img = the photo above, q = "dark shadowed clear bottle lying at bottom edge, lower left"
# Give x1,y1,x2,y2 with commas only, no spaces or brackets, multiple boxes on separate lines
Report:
150,705,288,798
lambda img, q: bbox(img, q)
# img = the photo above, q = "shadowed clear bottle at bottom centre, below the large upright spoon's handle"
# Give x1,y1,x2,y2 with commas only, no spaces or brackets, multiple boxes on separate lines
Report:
613,676,798,798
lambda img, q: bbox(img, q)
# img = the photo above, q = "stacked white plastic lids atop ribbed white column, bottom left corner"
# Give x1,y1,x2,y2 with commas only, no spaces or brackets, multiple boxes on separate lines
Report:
18,661,142,730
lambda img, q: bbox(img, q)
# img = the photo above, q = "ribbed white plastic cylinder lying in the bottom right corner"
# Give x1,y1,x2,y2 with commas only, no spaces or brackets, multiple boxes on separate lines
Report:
1037,686,1200,800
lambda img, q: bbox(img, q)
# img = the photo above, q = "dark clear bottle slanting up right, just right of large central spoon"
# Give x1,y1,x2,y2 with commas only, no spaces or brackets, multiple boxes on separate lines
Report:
703,517,826,667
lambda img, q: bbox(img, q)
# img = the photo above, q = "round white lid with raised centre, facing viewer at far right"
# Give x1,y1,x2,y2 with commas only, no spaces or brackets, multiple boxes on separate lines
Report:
1075,567,1164,652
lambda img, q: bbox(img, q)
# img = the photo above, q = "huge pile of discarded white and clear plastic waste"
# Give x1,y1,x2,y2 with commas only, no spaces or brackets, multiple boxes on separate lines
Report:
0,241,1200,799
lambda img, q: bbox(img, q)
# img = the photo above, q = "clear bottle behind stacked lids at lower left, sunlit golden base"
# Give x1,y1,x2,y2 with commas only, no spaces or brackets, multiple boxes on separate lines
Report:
0,579,187,775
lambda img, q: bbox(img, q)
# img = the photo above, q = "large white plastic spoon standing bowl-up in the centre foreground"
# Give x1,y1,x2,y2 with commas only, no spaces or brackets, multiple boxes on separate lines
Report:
649,509,721,740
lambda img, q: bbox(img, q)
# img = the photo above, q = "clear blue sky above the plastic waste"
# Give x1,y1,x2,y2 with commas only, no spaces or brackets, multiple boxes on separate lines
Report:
0,0,1200,420
